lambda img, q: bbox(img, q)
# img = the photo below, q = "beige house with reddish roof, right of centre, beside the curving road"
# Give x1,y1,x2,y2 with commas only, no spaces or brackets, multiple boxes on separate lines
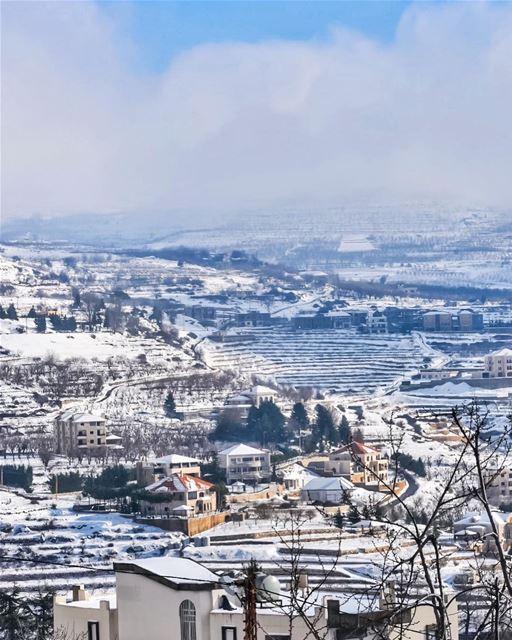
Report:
325,442,388,486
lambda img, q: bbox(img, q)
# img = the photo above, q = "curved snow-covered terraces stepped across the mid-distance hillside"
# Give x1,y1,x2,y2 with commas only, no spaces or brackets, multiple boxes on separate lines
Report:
202,328,427,394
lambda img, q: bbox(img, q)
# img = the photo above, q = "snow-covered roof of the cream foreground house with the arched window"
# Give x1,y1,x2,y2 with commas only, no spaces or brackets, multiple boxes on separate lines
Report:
114,556,219,589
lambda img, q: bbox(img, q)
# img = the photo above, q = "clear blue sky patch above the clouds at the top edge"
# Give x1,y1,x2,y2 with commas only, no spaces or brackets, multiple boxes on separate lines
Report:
102,0,414,71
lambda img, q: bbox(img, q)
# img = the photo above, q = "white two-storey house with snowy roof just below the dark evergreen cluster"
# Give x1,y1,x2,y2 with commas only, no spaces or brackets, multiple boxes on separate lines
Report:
218,444,271,484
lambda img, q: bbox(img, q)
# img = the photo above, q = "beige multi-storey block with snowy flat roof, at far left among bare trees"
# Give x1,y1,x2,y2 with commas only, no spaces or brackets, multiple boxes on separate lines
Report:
54,410,107,455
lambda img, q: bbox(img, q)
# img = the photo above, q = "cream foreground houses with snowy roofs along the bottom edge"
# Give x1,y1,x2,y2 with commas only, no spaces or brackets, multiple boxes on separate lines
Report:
54,557,458,640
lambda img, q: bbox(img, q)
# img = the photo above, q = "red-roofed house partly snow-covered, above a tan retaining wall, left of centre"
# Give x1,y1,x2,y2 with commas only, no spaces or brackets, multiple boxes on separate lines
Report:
140,473,217,516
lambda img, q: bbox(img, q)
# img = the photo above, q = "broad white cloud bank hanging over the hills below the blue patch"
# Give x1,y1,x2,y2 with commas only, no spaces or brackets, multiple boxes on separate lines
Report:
2,2,512,222
